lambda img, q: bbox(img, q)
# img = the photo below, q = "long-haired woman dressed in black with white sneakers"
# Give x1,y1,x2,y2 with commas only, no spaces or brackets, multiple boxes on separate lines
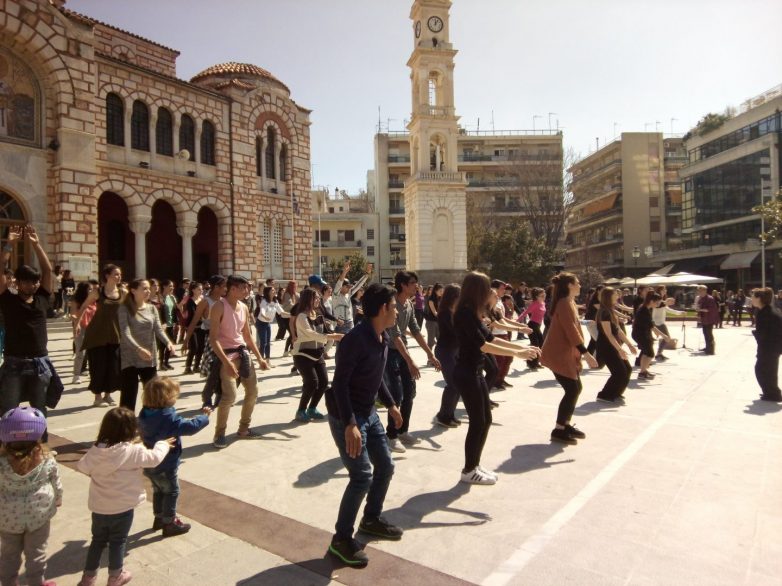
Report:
453,272,540,484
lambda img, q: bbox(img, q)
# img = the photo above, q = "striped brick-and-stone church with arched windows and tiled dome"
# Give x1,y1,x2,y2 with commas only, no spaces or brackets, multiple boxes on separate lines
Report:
0,0,312,278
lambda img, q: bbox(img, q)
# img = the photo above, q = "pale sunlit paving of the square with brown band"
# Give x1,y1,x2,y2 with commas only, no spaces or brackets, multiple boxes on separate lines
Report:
35,322,782,586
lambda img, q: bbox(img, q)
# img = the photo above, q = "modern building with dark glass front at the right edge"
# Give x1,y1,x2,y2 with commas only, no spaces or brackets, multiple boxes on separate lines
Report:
658,85,782,288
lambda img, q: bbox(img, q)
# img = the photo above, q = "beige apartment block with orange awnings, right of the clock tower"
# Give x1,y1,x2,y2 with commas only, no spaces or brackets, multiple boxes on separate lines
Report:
565,132,687,277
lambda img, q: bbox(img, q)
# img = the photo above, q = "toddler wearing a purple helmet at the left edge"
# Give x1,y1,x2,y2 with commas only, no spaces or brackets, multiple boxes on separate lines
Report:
0,407,62,586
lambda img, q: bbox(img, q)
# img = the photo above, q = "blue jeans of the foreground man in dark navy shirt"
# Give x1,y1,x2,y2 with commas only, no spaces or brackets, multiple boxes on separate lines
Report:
329,411,394,540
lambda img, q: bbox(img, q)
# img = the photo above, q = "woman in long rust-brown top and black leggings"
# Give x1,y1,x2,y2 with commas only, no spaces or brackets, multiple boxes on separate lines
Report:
540,272,597,444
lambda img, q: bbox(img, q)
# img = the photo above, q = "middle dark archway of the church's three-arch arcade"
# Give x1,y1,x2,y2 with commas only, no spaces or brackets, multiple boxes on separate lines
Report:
147,199,182,281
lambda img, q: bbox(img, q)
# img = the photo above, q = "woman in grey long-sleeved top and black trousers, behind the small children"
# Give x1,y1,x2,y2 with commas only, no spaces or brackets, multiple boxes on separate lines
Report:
117,279,174,411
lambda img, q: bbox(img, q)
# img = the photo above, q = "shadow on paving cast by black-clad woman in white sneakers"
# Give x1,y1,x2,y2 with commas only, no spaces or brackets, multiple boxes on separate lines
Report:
382,480,491,537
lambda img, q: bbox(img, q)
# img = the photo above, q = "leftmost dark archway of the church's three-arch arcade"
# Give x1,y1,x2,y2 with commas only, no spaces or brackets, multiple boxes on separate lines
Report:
98,191,136,279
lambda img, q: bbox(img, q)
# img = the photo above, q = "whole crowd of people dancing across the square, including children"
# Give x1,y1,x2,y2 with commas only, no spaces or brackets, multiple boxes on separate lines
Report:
0,221,782,586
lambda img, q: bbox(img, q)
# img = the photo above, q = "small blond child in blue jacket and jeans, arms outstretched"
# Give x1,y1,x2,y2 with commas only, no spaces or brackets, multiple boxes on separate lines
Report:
139,376,212,537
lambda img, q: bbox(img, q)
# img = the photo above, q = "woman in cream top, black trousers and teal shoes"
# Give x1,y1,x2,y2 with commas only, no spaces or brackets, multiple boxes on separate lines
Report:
293,289,343,423
